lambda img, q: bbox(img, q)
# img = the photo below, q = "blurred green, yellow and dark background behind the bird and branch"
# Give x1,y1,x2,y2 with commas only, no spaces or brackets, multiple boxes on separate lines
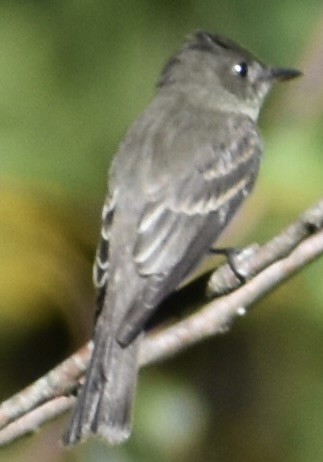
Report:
0,0,323,462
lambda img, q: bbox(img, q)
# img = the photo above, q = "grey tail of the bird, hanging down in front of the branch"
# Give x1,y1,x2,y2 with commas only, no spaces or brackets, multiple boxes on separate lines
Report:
63,317,141,446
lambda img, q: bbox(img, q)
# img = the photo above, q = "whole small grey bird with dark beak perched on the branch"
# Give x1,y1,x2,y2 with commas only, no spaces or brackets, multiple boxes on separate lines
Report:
64,31,300,445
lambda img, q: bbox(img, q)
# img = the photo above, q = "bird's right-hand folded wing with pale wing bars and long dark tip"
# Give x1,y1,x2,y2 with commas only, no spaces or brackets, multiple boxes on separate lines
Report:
119,113,262,344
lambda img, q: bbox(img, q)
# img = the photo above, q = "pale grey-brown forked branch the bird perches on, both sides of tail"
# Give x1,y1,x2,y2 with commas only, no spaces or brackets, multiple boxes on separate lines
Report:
0,199,323,446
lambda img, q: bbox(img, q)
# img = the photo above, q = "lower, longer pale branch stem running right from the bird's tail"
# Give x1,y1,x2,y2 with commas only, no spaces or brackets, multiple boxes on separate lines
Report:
142,230,323,365
